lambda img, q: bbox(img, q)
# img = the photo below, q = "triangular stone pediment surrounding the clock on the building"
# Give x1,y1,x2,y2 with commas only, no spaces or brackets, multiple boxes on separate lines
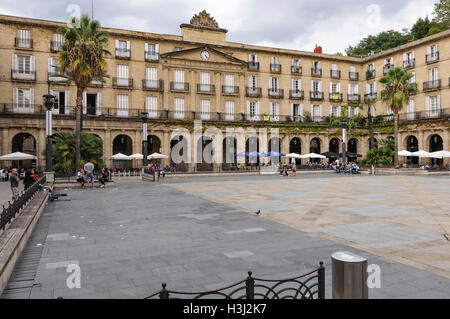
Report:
161,46,246,65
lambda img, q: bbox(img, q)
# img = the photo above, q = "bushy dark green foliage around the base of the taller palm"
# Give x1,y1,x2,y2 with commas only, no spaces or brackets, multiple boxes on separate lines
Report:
53,132,104,174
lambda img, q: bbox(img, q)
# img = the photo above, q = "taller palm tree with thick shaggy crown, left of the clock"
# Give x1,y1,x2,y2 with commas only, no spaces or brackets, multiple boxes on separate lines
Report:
58,15,111,170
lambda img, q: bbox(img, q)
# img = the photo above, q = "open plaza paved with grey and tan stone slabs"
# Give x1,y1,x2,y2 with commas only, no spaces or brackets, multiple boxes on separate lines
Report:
2,174,450,298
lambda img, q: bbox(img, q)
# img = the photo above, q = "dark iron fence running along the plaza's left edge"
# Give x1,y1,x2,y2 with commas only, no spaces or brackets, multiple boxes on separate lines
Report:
0,176,47,230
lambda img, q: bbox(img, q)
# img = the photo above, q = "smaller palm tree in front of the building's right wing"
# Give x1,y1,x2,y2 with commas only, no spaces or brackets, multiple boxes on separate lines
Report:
380,67,417,167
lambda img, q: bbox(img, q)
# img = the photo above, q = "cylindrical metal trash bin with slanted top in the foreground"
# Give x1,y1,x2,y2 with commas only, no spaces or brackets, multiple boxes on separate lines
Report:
331,251,369,299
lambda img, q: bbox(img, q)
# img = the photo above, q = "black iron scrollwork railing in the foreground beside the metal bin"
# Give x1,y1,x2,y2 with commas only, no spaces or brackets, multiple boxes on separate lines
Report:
144,262,325,299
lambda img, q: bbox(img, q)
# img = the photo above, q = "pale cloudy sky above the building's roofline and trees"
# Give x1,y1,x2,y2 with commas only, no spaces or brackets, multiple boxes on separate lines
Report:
0,0,438,54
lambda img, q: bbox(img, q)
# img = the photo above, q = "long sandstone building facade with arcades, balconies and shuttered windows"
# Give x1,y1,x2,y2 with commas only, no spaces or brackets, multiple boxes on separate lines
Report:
0,12,450,170
